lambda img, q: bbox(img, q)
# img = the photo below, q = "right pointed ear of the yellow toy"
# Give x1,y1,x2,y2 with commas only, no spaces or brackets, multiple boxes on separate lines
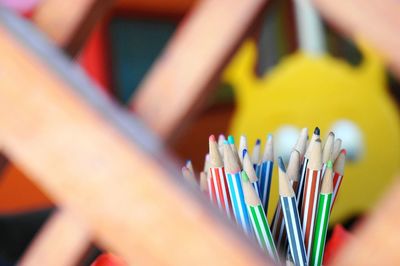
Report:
357,38,386,89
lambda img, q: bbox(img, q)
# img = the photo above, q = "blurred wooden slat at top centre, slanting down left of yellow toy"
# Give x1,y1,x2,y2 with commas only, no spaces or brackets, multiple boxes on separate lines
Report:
131,0,267,139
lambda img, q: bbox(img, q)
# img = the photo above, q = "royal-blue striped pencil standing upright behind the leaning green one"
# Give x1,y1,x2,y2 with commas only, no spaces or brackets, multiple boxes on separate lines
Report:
259,134,274,214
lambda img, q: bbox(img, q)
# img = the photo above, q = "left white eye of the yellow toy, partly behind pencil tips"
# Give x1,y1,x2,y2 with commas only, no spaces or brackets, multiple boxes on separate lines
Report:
274,125,300,163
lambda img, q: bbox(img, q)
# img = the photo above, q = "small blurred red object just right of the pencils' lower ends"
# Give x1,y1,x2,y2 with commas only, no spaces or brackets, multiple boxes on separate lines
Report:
322,225,353,265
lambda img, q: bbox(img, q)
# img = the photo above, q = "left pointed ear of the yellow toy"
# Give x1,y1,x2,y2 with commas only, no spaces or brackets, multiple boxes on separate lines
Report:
222,40,257,103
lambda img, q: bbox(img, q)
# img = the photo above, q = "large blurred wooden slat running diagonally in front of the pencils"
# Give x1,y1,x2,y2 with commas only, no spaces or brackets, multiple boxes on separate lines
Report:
0,10,268,265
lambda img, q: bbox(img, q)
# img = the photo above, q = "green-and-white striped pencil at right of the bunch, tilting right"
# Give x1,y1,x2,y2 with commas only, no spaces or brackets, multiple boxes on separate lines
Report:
310,161,333,266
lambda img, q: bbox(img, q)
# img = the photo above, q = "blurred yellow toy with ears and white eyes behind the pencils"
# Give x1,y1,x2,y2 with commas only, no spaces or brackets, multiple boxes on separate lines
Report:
224,41,400,222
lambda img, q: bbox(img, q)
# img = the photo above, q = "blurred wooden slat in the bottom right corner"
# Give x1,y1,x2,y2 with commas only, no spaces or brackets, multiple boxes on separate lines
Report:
332,178,400,266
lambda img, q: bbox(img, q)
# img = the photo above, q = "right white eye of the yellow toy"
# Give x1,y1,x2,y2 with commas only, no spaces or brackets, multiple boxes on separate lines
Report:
331,119,364,161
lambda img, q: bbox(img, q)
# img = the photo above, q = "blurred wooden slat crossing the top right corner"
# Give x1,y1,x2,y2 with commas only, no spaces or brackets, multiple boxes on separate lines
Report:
313,0,400,78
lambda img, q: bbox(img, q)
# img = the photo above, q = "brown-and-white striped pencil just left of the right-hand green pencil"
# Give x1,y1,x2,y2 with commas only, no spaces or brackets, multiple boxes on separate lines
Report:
301,139,322,258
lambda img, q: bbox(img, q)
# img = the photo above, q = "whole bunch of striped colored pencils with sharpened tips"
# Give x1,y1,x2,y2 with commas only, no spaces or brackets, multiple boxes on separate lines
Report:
182,127,346,265
